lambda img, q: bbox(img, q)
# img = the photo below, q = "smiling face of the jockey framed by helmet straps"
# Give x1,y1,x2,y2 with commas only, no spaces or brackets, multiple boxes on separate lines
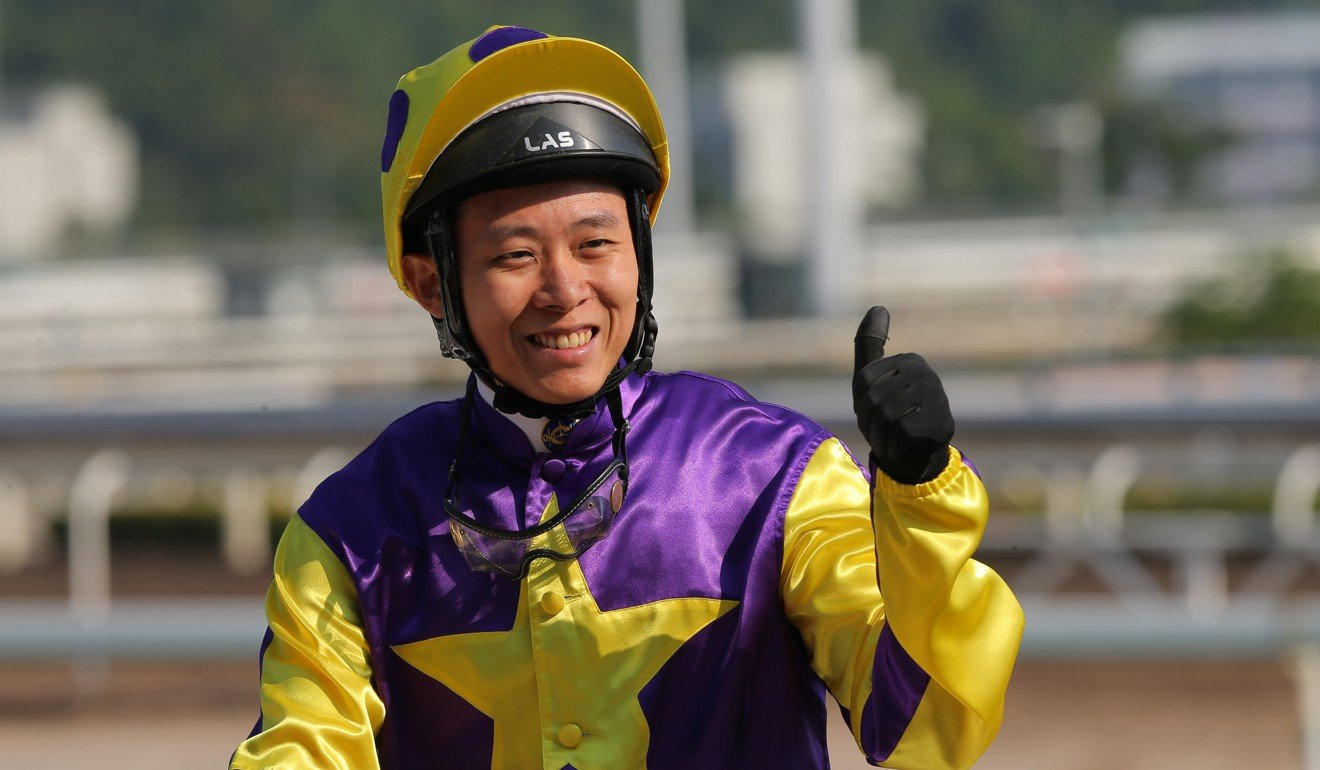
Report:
455,180,638,404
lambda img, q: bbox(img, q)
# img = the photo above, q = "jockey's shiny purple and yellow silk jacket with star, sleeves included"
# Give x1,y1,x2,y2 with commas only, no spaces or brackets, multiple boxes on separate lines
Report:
231,372,1022,770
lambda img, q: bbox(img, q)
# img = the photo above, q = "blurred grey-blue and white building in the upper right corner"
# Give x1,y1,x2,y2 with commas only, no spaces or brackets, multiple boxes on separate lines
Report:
1121,12,1320,202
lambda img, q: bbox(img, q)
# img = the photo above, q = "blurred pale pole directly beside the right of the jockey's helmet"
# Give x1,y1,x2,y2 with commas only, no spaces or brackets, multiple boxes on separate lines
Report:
638,0,696,232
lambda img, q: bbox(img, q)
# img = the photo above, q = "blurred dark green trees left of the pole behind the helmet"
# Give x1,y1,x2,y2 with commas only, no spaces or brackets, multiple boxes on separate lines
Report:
0,0,644,234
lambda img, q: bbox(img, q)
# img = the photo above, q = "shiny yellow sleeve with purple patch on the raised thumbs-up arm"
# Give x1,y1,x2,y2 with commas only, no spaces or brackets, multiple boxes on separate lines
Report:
780,438,1023,769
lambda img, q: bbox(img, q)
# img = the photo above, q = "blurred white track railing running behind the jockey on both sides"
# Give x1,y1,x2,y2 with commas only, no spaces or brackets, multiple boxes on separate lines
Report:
0,435,1320,688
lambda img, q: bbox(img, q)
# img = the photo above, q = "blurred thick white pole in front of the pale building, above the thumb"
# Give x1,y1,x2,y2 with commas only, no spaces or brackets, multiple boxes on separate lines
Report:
785,0,862,316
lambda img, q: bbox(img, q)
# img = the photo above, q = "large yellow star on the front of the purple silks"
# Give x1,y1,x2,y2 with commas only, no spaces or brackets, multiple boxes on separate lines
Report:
393,497,738,770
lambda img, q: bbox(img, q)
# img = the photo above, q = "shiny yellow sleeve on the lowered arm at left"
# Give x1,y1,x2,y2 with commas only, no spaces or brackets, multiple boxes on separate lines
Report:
230,516,385,770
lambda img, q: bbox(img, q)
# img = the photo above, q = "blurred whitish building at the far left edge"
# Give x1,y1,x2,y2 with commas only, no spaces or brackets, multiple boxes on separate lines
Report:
0,86,139,262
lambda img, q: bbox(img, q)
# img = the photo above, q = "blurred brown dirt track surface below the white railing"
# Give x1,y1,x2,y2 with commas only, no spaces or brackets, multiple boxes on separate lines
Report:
0,657,1302,770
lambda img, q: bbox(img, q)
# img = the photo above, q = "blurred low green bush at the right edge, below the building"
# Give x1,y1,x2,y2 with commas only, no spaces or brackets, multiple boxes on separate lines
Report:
1164,251,1320,347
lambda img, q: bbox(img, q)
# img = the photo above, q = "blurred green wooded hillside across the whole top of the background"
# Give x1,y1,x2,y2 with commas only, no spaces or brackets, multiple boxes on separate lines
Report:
0,0,1308,236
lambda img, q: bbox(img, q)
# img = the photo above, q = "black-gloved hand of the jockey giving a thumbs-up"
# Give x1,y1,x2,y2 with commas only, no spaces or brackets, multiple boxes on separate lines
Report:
853,306,953,483
